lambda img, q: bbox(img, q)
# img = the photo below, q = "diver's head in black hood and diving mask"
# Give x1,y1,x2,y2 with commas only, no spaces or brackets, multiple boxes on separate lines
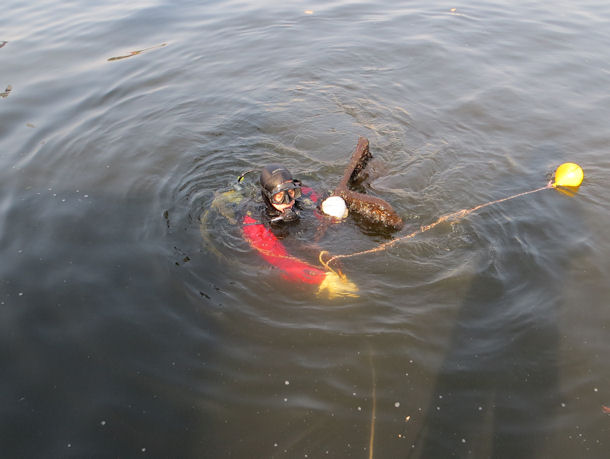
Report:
260,164,301,221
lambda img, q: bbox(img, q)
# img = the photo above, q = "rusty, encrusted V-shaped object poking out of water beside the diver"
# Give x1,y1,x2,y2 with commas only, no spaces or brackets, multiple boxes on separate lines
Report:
333,137,403,230
